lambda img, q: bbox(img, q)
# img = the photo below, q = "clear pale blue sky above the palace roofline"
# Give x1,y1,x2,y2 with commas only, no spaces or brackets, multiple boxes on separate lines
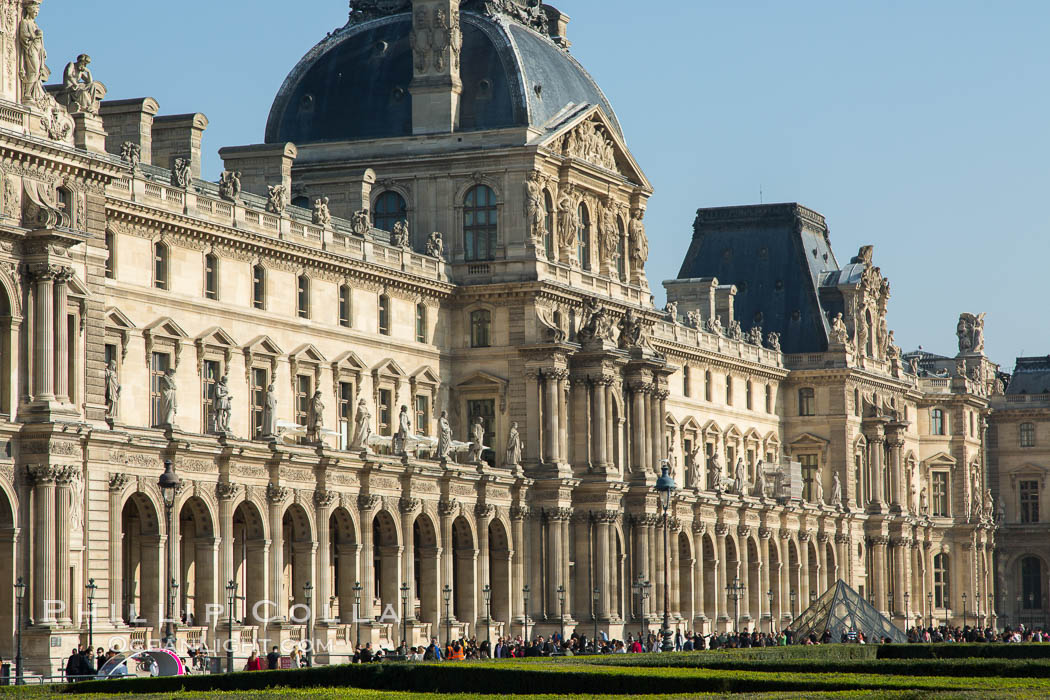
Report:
40,0,1050,368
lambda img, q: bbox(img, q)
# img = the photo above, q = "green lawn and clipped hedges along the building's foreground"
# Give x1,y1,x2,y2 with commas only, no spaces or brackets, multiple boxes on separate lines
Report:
8,644,1050,700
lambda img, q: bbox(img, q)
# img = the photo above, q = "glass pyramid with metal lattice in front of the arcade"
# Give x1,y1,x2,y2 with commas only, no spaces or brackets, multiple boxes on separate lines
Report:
792,578,907,644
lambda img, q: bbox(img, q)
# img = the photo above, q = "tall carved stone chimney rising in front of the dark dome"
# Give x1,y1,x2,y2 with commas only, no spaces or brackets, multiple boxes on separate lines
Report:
408,0,463,134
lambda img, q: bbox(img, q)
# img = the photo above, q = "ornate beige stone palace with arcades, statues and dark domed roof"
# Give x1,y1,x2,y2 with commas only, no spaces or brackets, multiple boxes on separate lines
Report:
0,0,995,671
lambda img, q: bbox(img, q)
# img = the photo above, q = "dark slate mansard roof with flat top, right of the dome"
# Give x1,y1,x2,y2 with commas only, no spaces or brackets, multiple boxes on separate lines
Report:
678,203,839,353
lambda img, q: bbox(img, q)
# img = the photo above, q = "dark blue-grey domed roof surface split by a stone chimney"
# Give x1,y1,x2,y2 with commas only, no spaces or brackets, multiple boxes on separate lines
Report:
266,12,623,144
